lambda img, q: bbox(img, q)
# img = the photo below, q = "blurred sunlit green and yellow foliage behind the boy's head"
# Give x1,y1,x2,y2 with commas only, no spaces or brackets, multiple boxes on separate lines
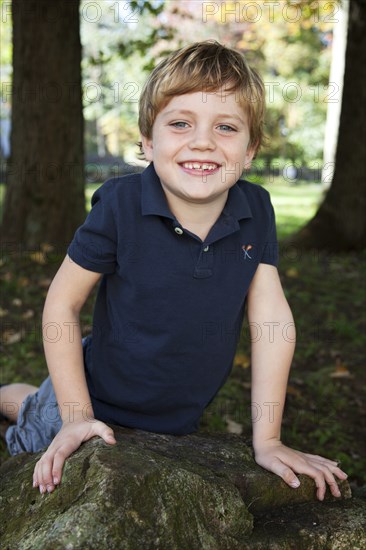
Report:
0,0,339,164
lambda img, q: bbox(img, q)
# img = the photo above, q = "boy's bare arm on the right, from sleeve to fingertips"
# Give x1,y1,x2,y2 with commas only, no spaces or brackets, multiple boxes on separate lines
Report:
248,264,347,500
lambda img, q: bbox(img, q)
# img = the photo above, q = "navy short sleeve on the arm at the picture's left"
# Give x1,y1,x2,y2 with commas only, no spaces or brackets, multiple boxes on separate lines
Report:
67,180,117,274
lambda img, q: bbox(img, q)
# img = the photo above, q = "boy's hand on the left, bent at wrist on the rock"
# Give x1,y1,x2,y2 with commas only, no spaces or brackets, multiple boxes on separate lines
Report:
33,418,116,494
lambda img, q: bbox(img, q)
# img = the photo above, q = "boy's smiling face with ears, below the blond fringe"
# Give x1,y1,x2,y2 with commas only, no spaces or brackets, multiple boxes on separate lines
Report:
141,90,254,212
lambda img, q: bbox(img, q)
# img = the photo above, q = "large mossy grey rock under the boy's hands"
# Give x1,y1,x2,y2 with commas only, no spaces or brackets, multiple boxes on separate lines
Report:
0,427,366,550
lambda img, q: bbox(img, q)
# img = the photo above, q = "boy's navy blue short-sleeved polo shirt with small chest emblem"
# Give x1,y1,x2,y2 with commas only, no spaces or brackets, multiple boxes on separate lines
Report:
68,164,278,434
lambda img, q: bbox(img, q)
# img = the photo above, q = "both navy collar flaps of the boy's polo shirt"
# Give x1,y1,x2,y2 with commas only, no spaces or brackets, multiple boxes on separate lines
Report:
141,163,253,221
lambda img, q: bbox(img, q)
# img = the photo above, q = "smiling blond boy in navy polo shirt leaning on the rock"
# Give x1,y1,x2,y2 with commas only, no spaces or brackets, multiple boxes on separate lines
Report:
1,41,347,500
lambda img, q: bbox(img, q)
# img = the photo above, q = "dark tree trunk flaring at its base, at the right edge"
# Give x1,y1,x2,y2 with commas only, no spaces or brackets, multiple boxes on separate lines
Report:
291,0,366,252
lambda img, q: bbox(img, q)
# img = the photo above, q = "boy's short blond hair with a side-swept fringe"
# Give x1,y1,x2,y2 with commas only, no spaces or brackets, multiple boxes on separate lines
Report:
138,40,265,156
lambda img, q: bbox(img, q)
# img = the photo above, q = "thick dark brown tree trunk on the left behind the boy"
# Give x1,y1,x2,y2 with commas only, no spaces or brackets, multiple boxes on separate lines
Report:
1,0,85,252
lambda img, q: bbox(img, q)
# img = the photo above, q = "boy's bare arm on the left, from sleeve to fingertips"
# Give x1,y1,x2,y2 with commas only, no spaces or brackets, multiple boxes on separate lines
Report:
33,256,115,493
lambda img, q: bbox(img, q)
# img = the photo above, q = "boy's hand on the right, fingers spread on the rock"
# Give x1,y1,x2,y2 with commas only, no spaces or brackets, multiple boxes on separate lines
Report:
254,440,348,500
